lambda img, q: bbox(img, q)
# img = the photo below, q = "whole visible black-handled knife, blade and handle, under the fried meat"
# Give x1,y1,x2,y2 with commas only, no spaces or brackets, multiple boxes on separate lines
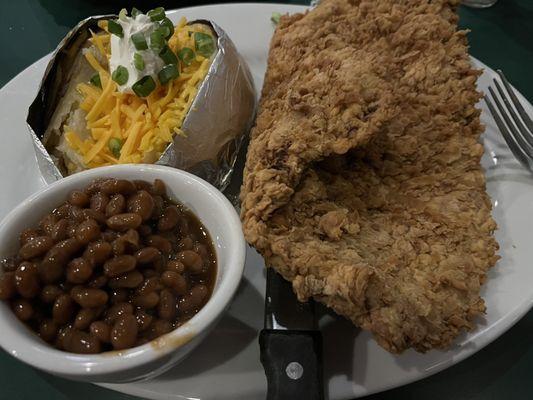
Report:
259,268,324,400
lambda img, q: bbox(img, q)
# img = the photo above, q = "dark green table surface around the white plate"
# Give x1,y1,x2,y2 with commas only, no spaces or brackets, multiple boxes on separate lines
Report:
0,0,533,400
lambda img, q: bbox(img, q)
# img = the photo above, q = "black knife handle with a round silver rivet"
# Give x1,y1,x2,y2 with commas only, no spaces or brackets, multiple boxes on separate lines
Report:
259,329,324,400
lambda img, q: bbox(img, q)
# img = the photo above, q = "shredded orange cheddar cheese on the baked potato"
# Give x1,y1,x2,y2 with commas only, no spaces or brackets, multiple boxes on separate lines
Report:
62,18,216,173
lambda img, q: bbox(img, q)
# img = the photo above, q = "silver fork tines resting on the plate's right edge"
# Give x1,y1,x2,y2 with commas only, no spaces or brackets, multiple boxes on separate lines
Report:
484,70,533,172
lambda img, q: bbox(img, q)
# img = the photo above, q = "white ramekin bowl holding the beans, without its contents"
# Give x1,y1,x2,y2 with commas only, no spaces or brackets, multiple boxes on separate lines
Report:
0,165,245,382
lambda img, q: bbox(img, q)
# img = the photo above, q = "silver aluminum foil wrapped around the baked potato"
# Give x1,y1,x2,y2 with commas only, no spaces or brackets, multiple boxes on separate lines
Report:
27,15,256,190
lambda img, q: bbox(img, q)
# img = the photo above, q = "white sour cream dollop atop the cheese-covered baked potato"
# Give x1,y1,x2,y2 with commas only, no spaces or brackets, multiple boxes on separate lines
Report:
109,14,164,93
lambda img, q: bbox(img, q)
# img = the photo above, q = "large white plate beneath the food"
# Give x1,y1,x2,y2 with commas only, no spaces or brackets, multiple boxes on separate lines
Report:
0,4,533,400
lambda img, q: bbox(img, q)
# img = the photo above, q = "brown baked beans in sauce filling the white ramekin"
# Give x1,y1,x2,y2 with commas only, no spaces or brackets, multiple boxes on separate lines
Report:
0,178,217,354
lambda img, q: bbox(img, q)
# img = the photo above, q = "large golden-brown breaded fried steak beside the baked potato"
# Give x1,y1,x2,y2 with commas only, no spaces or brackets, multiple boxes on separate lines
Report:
241,0,498,353
